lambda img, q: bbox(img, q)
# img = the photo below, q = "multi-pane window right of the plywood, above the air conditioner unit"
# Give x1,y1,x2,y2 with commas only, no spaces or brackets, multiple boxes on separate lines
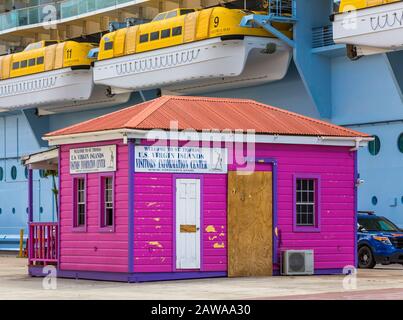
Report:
296,178,316,227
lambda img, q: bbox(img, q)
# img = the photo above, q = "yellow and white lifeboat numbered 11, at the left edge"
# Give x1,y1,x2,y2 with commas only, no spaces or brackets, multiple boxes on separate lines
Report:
0,41,130,114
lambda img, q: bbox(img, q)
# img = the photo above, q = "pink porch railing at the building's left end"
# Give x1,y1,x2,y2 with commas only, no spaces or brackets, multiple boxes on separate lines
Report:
29,222,58,265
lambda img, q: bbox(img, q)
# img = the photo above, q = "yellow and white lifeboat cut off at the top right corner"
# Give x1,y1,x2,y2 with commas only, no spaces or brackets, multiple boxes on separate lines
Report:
333,0,403,58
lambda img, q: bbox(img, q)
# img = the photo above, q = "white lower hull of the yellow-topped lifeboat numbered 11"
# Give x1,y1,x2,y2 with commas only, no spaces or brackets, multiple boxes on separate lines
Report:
0,68,130,114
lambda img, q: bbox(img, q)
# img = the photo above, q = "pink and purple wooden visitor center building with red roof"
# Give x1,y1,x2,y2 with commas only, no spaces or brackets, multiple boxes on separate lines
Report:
25,96,371,282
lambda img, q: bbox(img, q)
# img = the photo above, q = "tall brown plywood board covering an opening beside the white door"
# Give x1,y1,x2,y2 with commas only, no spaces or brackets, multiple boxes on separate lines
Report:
228,172,273,277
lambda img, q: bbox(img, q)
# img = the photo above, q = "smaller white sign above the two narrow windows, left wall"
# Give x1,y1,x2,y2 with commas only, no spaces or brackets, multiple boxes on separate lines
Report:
70,145,116,174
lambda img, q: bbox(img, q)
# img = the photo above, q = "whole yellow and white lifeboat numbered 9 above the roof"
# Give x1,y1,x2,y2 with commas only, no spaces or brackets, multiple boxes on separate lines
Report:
94,7,292,93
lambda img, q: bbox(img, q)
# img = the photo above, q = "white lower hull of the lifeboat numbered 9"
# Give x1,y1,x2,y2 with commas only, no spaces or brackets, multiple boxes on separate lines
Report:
94,37,292,93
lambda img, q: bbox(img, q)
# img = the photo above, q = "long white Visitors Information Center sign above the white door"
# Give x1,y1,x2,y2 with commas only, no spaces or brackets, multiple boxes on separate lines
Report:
134,146,228,174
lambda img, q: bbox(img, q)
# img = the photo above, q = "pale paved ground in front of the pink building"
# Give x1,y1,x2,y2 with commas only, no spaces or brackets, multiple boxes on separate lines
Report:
0,254,403,300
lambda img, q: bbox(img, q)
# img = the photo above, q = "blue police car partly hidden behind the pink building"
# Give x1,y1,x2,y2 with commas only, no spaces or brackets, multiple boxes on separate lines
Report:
358,211,403,269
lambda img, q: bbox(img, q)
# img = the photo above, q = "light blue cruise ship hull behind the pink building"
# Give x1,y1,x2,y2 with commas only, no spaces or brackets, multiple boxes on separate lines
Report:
0,0,403,250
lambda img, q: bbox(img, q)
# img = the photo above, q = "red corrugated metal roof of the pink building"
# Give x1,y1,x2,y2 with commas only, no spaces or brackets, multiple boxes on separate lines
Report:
46,96,369,137
